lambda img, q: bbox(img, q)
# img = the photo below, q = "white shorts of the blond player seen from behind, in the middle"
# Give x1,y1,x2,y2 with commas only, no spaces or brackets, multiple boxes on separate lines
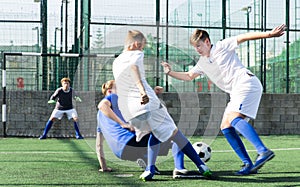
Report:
129,106,177,142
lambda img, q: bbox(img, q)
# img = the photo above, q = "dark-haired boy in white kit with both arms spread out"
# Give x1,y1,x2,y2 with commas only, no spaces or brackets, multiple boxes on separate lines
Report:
162,24,286,175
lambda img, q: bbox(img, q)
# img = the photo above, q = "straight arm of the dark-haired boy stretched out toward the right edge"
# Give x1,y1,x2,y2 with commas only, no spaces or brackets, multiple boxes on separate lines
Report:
237,24,286,44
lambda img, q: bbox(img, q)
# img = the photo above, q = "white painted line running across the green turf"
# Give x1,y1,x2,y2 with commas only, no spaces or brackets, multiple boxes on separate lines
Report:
0,148,300,154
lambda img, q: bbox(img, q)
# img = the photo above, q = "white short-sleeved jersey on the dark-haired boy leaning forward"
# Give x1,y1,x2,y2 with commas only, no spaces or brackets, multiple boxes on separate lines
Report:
191,37,254,94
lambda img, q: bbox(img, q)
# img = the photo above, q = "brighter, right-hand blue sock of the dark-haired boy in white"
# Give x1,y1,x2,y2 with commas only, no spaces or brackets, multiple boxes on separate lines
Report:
231,117,268,154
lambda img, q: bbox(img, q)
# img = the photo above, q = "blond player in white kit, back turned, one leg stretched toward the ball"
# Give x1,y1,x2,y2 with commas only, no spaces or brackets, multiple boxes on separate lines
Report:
113,30,212,181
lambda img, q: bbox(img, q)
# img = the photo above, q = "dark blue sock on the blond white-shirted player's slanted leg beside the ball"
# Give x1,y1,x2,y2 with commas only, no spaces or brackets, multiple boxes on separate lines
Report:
173,130,205,168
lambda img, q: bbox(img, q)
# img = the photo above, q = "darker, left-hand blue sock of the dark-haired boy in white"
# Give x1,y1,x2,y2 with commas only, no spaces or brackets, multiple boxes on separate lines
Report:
222,127,252,164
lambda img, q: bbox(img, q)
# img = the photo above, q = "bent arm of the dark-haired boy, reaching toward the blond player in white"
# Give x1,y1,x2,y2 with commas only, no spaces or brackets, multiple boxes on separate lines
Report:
161,62,199,81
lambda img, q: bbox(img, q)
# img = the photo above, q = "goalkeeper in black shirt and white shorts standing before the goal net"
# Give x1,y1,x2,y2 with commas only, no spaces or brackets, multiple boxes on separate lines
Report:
39,77,83,140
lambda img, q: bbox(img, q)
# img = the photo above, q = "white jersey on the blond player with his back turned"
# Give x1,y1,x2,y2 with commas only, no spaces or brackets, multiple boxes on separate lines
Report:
113,50,160,121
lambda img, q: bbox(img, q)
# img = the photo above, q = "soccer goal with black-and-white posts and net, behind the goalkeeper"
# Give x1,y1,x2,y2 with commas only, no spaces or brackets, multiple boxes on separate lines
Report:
0,53,116,137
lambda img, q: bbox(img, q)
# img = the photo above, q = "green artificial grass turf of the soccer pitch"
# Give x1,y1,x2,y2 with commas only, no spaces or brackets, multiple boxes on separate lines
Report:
0,135,300,187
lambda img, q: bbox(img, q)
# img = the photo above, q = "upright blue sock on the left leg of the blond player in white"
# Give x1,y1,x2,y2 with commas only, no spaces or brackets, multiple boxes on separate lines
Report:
146,134,160,173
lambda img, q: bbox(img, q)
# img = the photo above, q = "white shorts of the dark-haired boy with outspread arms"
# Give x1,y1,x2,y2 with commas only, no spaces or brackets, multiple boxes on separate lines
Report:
224,76,262,119
